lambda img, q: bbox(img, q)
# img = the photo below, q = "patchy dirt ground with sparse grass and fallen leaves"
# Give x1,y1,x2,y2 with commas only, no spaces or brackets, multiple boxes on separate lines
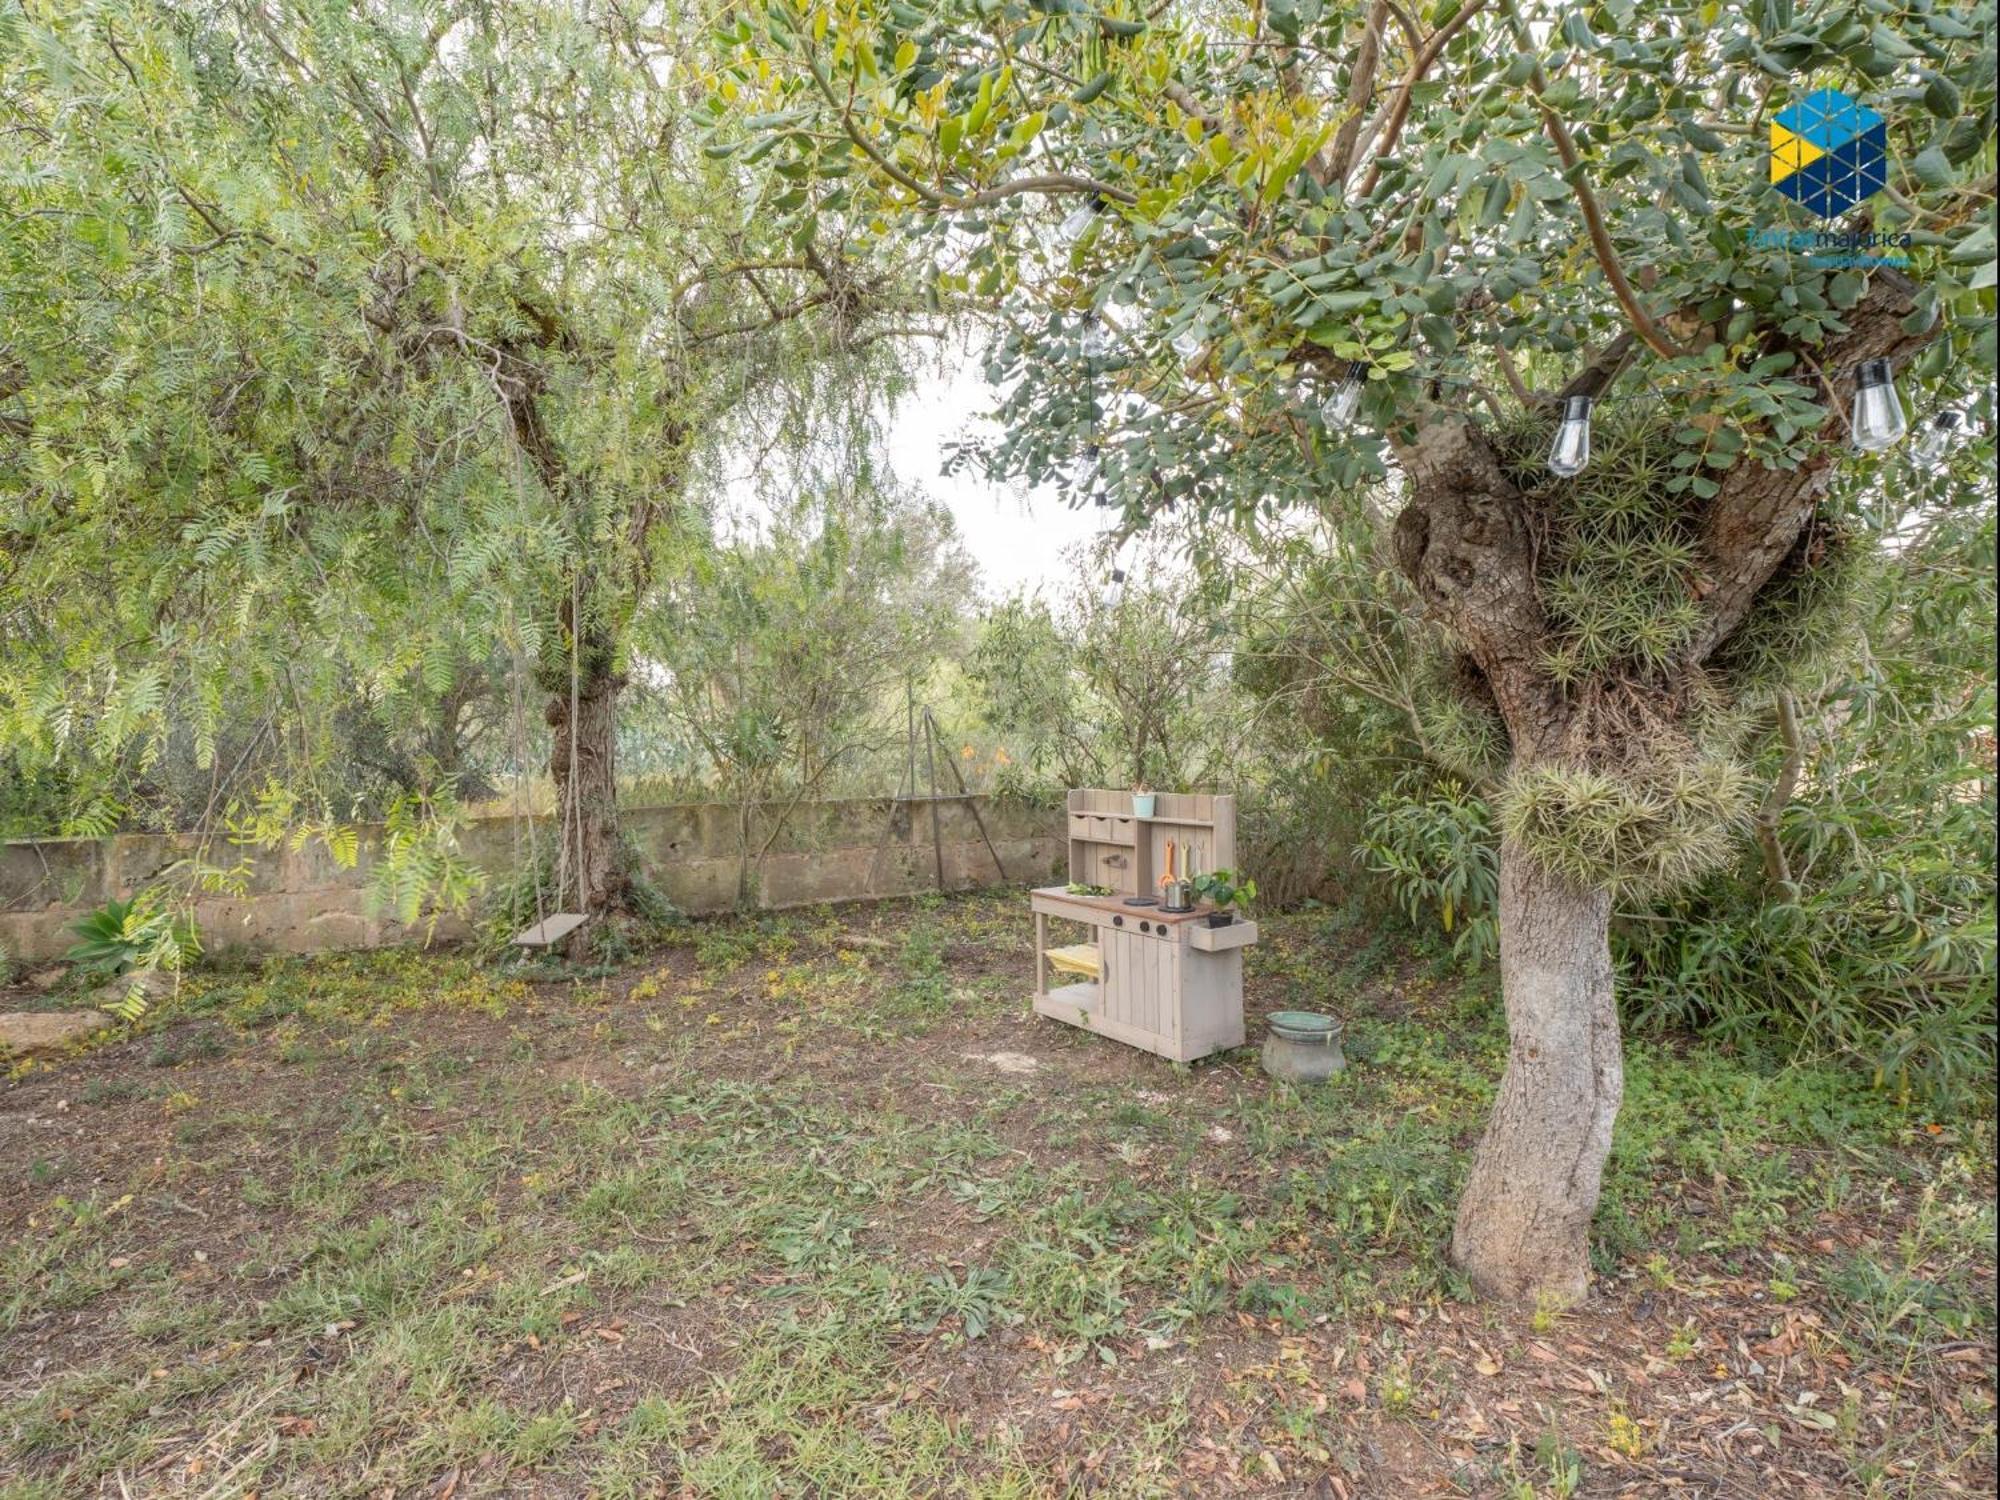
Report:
0,894,1996,1500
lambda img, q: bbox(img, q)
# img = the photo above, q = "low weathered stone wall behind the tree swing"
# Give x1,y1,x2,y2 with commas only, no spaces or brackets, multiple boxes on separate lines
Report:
0,798,1064,958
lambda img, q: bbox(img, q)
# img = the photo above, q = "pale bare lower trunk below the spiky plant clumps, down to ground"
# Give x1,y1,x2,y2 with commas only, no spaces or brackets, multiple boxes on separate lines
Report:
1452,844,1624,1302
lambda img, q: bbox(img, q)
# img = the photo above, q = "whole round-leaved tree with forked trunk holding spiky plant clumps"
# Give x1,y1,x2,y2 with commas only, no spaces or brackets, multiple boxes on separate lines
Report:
716,0,1994,1298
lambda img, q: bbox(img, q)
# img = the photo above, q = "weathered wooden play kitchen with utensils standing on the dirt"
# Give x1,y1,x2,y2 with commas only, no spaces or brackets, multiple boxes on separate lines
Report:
1028,788,1256,1062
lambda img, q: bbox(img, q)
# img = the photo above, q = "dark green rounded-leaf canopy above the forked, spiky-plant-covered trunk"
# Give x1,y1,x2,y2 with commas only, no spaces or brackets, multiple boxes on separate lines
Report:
728,0,1994,506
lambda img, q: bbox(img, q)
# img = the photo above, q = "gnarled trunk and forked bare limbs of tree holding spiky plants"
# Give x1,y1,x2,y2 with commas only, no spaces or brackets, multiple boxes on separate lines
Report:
1392,270,1932,1298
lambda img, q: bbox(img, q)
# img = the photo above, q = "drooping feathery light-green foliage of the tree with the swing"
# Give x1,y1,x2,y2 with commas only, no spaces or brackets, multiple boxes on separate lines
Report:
0,0,916,892
